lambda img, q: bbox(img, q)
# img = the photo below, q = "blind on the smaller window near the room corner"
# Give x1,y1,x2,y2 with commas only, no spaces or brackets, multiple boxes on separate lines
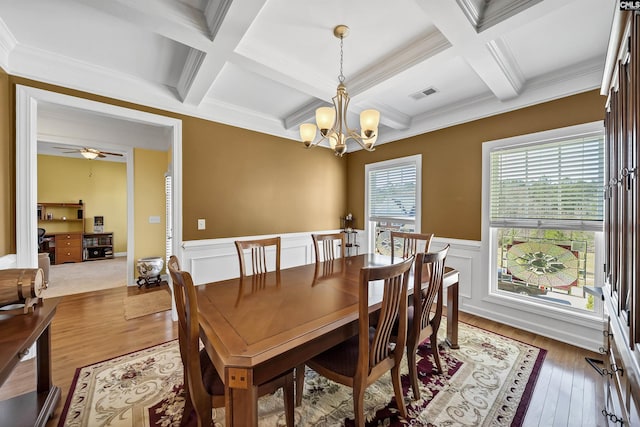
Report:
369,163,417,220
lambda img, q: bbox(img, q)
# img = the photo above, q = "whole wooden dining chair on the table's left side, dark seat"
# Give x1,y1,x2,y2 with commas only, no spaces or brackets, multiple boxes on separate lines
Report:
167,255,294,427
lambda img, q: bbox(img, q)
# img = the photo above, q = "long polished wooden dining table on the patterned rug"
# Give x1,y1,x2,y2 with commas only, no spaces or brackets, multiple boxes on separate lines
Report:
196,254,458,426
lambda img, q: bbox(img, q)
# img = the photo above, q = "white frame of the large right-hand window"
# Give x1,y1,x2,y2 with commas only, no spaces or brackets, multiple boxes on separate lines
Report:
482,121,604,321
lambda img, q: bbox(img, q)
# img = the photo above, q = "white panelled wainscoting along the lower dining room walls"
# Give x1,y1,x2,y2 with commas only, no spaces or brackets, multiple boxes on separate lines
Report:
178,230,603,351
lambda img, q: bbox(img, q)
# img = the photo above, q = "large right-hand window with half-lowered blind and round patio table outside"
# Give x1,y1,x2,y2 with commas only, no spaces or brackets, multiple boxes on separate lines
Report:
484,123,604,312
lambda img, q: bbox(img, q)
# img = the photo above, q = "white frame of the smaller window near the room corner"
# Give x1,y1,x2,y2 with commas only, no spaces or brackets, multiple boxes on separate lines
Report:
364,154,422,253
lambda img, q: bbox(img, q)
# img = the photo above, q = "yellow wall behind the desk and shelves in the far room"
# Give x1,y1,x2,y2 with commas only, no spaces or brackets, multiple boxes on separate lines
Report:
38,155,127,252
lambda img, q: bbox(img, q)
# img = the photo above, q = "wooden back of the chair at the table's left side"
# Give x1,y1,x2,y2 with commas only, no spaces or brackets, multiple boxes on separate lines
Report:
167,255,218,426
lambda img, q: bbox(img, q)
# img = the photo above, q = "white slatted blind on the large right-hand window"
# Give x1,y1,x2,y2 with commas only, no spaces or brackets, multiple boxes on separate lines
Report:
490,132,604,229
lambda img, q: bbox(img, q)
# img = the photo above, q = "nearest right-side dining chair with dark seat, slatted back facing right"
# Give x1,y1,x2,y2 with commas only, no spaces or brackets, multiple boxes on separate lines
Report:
307,257,413,427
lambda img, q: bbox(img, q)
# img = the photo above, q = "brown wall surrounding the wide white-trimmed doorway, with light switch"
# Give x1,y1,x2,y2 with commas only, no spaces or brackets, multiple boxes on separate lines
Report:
0,75,347,251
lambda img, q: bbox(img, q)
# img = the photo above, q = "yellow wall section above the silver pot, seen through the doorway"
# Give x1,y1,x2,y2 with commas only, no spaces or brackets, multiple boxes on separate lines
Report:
133,149,168,276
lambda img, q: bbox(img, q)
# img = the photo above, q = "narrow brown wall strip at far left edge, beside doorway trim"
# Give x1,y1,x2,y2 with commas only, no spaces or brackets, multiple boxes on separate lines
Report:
0,69,16,256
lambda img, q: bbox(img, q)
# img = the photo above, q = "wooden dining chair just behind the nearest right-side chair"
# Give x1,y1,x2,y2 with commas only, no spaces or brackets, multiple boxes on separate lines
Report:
394,245,449,400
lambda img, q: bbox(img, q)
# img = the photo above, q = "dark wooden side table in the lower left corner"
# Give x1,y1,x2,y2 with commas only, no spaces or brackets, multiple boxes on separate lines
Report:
0,298,60,427
